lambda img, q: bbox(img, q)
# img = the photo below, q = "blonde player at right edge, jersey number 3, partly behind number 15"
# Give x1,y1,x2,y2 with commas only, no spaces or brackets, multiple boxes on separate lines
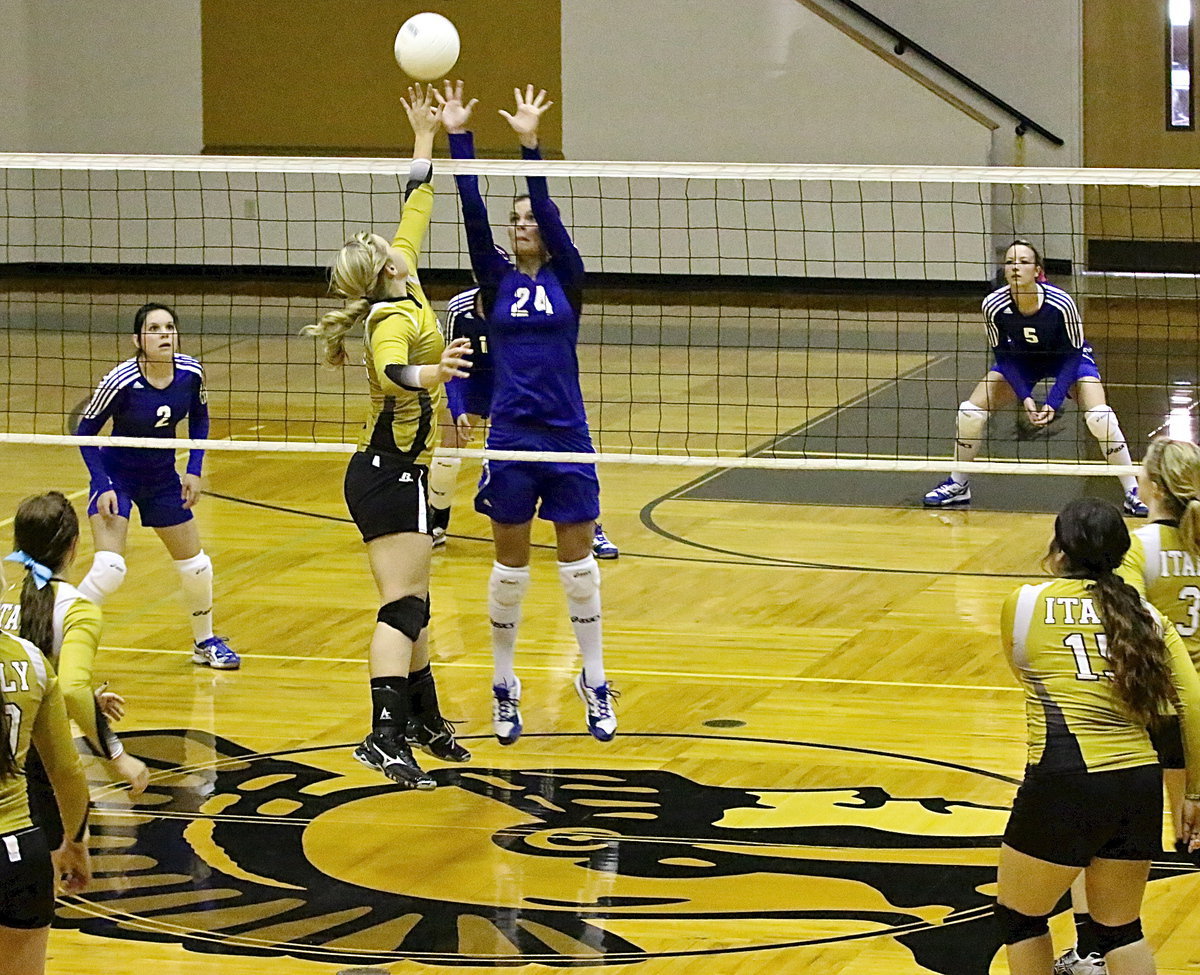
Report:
1055,439,1200,975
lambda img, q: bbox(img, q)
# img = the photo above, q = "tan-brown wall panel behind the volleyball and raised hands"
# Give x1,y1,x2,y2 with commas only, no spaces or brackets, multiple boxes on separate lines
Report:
202,0,563,156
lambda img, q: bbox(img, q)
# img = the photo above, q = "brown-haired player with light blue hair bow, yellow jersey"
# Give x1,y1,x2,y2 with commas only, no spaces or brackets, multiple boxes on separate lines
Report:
0,491,150,849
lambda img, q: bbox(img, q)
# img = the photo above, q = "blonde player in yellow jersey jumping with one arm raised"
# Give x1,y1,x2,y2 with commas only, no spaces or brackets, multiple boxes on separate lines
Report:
304,86,470,789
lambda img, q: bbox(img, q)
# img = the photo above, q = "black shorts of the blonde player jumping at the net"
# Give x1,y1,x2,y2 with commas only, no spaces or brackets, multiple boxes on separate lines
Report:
344,450,431,542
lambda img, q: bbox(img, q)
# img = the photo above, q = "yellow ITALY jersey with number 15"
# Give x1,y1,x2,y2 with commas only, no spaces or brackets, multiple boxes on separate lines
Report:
1001,579,1200,792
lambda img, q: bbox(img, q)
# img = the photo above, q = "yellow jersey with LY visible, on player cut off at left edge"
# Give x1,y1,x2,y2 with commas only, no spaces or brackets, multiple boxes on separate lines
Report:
0,632,88,837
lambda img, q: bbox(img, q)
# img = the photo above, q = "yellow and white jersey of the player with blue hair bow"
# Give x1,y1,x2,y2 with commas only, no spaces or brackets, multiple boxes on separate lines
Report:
0,579,125,759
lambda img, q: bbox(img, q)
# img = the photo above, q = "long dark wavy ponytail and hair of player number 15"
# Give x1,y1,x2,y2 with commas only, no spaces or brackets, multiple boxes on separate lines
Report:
1051,498,1174,725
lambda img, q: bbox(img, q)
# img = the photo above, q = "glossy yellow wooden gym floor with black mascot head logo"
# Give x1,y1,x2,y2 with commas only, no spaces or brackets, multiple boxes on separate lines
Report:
0,285,1200,975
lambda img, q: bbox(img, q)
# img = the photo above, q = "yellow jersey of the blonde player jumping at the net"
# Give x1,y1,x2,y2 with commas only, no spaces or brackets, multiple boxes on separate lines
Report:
359,183,445,465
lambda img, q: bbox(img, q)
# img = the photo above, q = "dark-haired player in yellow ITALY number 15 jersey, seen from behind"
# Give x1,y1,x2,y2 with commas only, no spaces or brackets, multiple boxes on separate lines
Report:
996,498,1200,975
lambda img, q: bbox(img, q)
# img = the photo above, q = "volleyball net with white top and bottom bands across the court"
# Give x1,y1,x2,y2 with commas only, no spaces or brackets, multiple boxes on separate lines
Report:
0,154,1200,474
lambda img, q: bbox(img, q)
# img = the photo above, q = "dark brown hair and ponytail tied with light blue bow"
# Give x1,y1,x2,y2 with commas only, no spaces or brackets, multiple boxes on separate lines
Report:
12,491,79,656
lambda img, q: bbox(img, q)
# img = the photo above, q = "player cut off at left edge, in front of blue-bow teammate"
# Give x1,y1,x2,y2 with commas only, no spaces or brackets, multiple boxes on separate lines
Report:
0,564,91,975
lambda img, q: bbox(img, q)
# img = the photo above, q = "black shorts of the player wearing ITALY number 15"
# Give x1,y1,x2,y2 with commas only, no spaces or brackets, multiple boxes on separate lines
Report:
1004,765,1163,867
